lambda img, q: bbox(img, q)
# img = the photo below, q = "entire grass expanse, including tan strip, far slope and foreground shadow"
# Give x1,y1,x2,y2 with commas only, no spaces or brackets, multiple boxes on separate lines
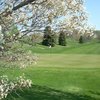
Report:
0,41,100,100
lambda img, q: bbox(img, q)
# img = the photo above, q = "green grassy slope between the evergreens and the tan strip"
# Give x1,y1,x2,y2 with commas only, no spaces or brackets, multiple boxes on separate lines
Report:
23,40,100,54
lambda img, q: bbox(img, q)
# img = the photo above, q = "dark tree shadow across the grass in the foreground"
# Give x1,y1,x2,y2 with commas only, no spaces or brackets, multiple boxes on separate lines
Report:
5,85,95,100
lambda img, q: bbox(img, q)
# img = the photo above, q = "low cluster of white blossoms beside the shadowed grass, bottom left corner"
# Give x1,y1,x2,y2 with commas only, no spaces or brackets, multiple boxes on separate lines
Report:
0,75,32,100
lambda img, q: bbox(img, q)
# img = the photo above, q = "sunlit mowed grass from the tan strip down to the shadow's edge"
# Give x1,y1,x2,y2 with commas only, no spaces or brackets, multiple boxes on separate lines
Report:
0,54,100,100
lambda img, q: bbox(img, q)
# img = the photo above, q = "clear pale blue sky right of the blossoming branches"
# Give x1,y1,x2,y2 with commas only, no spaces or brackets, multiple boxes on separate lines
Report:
85,0,100,30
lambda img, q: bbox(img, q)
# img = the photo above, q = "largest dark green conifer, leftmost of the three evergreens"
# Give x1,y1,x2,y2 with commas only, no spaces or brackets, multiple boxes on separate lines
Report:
42,26,56,47
